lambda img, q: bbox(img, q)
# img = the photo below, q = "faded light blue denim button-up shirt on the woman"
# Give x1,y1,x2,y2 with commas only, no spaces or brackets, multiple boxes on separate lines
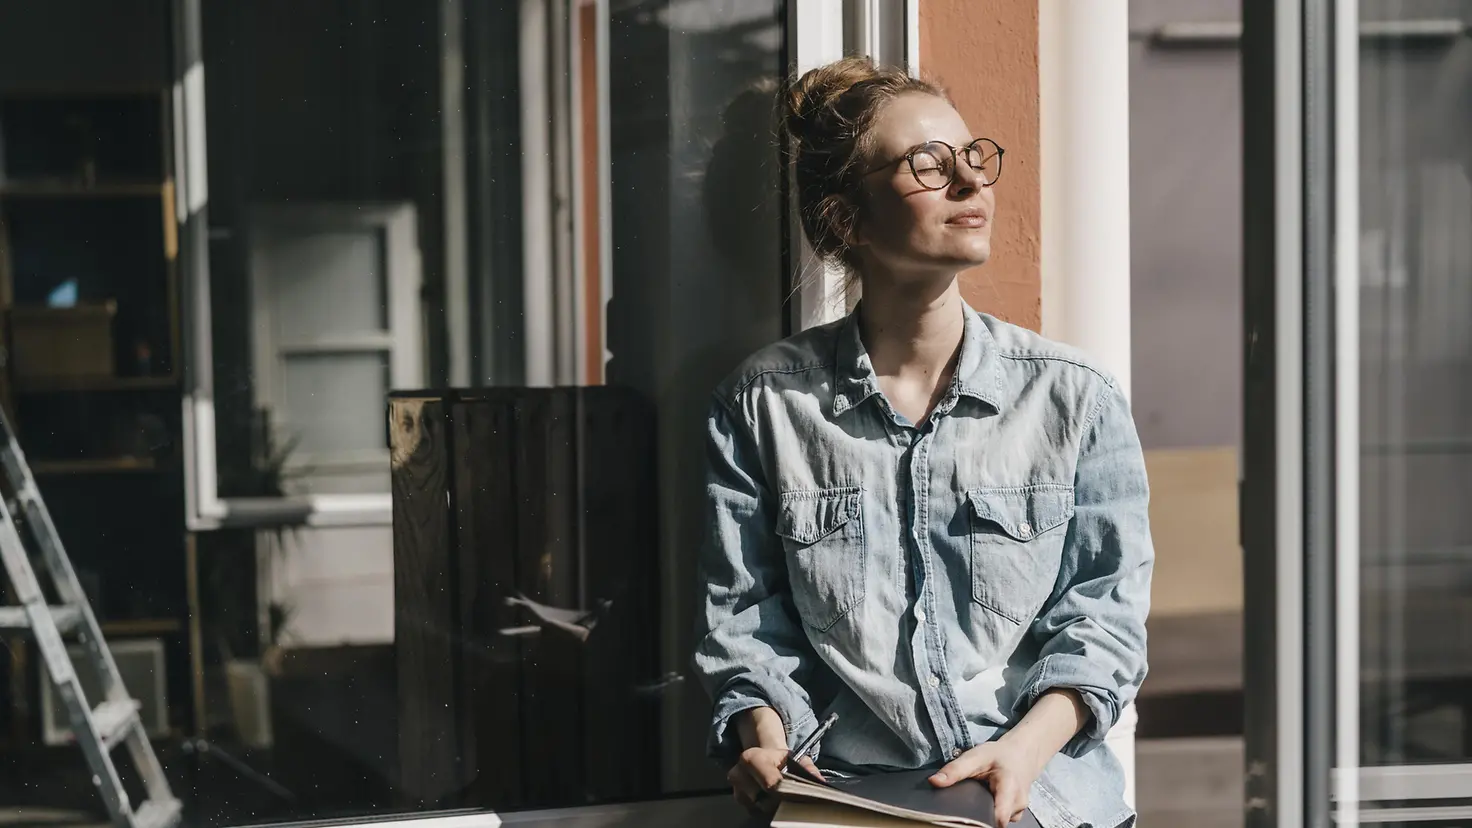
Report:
695,308,1154,828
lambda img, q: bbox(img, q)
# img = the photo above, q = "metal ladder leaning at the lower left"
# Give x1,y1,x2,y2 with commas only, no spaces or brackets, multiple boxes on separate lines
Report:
0,411,183,828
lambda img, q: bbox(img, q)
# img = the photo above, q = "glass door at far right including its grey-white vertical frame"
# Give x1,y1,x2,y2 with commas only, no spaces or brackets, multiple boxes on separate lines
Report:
1242,0,1472,827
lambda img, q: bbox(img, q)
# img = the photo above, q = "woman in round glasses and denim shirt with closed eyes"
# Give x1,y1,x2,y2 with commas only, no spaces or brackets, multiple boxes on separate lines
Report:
695,59,1154,828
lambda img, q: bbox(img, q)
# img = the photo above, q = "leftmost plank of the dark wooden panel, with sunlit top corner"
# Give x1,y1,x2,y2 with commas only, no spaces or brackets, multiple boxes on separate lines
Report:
389,398,461,804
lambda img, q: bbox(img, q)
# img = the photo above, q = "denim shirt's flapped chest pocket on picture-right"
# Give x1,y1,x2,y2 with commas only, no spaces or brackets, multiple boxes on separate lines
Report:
967,485,1073,623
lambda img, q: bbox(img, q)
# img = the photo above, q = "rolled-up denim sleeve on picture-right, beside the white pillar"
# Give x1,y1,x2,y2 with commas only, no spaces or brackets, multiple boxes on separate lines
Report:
1019,383,1156,756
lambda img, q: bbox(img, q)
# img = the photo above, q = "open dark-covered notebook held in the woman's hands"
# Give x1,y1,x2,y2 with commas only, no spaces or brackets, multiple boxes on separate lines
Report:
771,766,997,828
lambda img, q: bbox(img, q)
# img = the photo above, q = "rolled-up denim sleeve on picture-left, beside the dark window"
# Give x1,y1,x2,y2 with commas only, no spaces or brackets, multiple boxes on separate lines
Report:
693,399,817,763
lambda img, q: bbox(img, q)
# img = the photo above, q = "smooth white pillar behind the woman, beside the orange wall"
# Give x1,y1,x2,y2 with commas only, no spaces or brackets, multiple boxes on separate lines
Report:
1038,0,1138,806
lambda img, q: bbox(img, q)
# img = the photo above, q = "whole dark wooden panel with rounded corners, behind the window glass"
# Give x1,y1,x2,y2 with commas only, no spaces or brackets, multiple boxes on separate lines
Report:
394,387,661,809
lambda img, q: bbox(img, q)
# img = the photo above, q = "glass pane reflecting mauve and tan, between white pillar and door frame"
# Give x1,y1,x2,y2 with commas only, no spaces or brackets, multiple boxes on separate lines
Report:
1128,0,1245,825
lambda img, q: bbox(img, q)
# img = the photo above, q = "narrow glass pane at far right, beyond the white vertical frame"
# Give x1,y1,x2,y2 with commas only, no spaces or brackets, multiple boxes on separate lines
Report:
1359,1,1472,765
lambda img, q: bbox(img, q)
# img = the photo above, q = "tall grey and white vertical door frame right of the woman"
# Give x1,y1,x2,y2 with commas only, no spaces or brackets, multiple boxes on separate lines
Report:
1241,0,1363,828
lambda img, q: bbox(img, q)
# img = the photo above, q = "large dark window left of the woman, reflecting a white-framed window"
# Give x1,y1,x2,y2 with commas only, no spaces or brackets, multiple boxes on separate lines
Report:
0,0,913,825
